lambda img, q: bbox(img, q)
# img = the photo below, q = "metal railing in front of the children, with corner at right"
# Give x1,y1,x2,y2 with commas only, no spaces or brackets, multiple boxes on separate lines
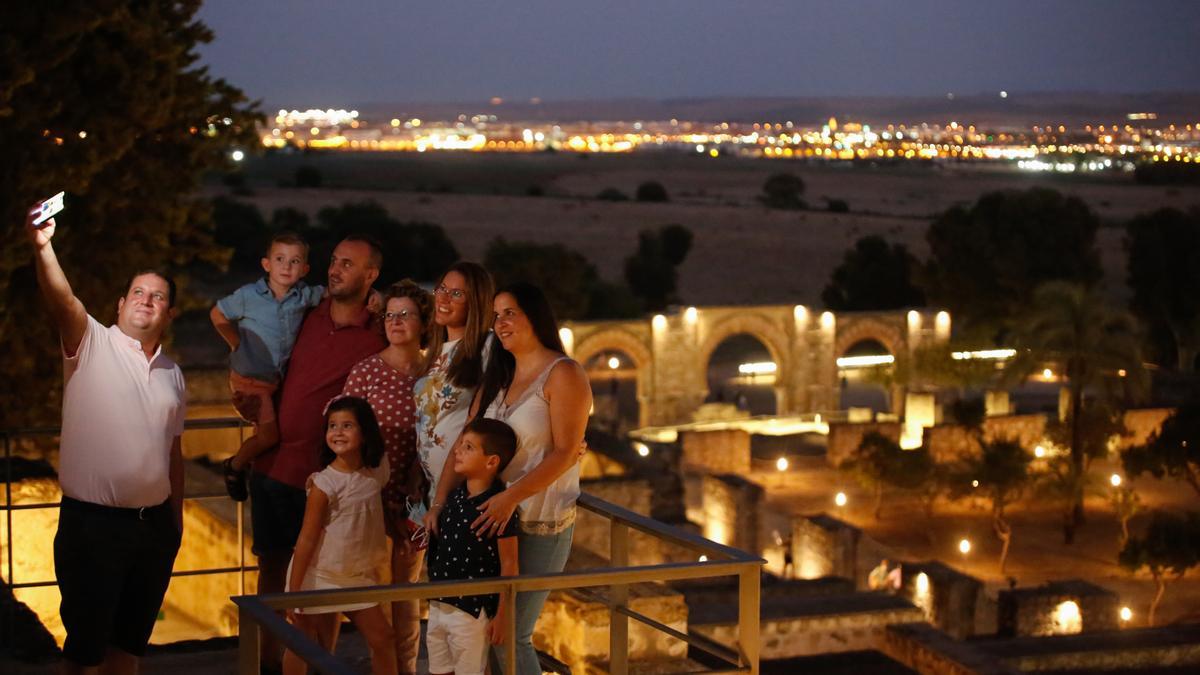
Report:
233,494,764,675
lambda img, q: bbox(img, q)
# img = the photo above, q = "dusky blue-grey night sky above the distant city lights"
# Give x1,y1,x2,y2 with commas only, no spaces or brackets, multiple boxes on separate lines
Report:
200,0,1200,108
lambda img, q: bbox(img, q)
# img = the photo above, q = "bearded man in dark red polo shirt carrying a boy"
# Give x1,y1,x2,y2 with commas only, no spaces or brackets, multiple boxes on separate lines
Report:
250,235,386,669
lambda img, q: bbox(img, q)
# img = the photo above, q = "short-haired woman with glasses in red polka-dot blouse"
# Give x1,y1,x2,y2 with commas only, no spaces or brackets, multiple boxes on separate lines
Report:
342,279,433,673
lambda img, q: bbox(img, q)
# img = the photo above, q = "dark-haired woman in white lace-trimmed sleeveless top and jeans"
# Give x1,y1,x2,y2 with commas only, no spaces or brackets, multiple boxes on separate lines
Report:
433,283,592,675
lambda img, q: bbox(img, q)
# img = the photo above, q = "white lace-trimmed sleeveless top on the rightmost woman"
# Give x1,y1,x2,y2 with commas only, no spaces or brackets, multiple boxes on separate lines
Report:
484,357,580,534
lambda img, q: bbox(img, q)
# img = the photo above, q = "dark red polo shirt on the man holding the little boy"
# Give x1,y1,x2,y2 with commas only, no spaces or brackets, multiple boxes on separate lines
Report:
254,298,386,489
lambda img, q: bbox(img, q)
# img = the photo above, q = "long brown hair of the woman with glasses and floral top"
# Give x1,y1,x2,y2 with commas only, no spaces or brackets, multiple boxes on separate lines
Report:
428,261,496,389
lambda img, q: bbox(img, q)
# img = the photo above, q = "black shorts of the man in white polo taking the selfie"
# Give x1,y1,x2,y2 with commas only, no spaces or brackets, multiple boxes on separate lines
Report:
54,497,180,667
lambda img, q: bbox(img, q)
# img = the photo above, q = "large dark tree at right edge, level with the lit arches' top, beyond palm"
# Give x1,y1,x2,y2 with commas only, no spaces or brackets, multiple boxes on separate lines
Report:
1126,208,1200,372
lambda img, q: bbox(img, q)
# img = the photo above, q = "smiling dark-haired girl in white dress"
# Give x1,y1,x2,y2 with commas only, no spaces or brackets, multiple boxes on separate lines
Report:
283,396,396,675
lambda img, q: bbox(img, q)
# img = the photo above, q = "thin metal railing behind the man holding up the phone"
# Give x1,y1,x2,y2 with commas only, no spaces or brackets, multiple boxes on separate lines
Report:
0,417,258,631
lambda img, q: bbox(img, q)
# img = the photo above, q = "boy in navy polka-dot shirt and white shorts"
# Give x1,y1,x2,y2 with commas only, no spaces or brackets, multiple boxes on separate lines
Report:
425,418,520,675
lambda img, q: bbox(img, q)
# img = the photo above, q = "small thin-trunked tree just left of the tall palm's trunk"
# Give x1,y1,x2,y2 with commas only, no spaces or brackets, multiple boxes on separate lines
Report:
954,438,1031,574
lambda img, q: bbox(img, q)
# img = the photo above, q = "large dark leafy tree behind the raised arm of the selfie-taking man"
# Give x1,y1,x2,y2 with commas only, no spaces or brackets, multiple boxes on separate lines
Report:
0,0,262,426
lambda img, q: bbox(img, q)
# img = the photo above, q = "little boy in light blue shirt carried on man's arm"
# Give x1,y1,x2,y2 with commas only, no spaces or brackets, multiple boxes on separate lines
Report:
209,233,325,502
